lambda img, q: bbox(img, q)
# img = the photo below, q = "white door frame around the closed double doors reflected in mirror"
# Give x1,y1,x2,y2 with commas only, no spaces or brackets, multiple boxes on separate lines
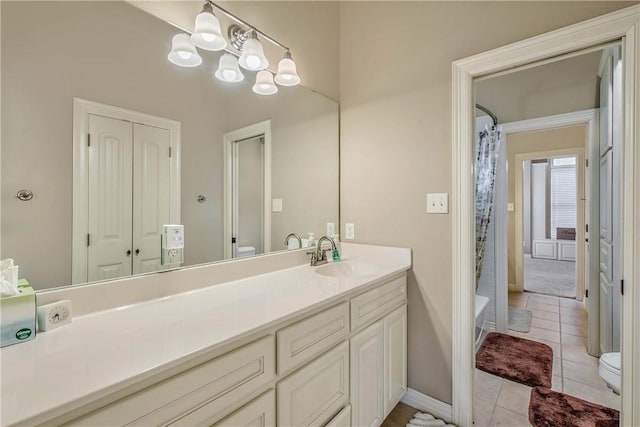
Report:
71,98,181,284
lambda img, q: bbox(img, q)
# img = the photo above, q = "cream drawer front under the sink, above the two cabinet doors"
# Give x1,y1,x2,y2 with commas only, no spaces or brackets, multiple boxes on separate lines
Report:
351,276,407,331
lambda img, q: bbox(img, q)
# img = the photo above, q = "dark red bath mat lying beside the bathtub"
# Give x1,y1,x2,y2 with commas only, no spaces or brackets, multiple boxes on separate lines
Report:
476,332,553,388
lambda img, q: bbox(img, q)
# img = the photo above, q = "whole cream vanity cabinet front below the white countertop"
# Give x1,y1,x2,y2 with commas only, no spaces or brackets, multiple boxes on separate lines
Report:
60,273,407,427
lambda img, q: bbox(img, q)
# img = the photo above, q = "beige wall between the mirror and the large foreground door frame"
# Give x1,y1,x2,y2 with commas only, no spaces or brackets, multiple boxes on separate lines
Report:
340,2,631,402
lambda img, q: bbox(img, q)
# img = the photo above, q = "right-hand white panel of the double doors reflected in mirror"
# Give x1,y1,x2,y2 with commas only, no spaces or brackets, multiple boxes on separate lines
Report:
132,123,171,274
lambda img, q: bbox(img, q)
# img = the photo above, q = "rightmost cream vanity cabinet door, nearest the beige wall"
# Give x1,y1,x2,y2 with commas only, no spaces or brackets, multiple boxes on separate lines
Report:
383,304,407,417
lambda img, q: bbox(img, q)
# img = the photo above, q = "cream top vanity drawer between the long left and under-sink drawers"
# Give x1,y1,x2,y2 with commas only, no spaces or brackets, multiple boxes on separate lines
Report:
277,302,349,375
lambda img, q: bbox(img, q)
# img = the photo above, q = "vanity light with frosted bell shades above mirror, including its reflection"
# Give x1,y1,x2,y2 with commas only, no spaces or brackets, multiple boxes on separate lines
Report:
167,0,300,95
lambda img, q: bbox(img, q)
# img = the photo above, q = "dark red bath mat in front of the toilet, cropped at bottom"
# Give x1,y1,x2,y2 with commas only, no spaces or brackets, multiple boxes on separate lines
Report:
529,387,620,427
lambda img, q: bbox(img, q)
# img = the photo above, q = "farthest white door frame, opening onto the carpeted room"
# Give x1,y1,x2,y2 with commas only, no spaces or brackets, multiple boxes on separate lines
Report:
514,148,585,299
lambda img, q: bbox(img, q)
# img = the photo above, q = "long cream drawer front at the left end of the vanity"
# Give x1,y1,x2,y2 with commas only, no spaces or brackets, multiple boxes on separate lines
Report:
66,335,275,426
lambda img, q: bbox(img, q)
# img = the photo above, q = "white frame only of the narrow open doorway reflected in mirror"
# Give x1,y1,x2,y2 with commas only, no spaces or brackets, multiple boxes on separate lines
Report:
222,120,271,259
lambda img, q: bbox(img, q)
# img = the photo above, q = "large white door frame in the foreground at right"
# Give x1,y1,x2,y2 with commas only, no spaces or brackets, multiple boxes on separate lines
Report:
451,5,640,425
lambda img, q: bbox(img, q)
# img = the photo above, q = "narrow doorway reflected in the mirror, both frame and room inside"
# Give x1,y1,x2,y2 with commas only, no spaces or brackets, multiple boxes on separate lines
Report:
224,120,271,259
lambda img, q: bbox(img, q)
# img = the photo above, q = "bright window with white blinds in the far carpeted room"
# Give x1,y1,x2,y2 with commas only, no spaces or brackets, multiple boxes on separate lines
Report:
551,157,577,239
